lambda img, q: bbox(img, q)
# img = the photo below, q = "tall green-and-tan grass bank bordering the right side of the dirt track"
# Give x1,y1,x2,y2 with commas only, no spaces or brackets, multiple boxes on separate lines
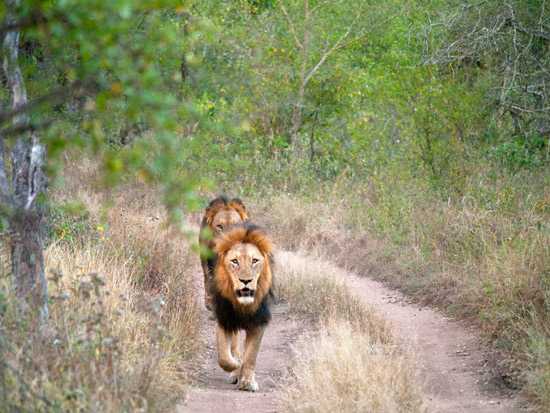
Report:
252,176,550,405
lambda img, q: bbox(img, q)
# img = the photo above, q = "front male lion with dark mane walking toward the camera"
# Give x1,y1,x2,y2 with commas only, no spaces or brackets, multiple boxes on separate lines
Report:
209,222,273,391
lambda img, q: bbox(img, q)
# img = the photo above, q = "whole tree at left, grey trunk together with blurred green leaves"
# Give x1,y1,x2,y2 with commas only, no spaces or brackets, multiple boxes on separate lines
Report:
0,0,203,321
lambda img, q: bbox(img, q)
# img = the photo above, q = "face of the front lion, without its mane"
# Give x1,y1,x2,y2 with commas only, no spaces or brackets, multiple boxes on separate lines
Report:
223,243,265,305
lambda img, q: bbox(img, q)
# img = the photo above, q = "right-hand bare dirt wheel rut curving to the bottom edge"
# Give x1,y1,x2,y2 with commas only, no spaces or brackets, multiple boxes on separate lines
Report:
345,268,522,413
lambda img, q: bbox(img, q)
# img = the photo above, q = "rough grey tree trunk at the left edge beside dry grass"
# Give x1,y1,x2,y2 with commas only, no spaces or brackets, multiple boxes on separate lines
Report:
0,0,48,322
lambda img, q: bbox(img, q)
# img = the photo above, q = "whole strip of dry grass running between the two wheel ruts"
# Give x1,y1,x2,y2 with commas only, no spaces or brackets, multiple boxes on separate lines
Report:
276,252,423,413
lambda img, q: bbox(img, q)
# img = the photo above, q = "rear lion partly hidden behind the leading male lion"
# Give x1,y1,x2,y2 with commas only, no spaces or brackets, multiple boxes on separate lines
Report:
199,195,248,310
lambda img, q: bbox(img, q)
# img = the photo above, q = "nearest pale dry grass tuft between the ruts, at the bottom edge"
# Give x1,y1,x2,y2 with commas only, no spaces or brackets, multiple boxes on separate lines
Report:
283,320,424,413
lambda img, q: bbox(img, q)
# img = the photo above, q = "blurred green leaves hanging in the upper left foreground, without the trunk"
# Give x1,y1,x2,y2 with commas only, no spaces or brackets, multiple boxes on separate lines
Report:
3,0,209,219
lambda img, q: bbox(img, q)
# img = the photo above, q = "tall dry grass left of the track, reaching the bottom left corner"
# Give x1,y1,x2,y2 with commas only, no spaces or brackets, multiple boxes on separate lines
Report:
4,232,198,412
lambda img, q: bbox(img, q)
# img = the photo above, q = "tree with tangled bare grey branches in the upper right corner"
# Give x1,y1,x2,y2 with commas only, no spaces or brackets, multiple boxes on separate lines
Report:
427,0,550,145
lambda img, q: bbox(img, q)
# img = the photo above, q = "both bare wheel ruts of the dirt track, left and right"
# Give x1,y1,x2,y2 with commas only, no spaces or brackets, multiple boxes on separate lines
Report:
178,252,522,413
